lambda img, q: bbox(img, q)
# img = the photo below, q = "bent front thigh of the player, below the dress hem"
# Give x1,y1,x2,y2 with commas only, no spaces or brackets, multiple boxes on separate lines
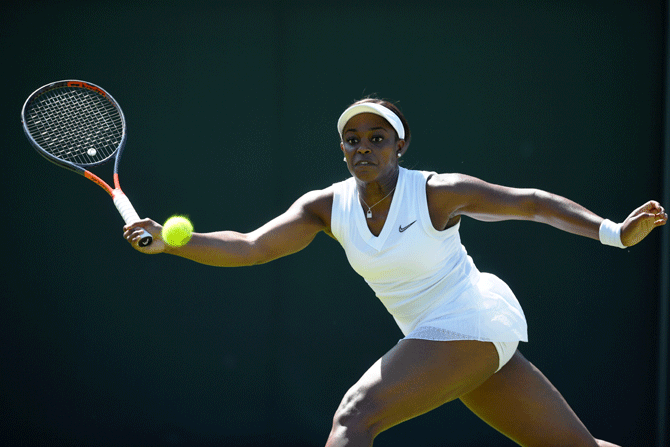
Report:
335,339,498,434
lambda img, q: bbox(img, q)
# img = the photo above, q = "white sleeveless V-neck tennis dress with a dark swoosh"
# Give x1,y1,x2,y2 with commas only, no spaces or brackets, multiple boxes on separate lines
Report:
331,168,528,342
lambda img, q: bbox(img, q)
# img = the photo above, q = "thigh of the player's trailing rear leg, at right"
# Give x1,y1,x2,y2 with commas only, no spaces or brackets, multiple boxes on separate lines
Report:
461,351,598,447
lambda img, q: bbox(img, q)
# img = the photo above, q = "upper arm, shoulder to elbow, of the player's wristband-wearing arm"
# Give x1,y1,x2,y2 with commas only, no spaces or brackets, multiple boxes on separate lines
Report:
429,174,538,221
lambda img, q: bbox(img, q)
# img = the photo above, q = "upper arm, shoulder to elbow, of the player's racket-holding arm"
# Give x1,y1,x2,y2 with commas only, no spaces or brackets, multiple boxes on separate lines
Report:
247,189,333,264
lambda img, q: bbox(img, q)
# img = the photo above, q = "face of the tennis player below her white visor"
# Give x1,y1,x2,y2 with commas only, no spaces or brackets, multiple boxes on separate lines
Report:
341,113,405,182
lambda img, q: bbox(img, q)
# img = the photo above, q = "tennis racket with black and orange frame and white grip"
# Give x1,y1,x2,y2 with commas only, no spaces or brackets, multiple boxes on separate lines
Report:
21,80,153,247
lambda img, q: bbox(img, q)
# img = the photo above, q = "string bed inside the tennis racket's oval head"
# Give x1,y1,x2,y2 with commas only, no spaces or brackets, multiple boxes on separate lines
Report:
26,87,124,165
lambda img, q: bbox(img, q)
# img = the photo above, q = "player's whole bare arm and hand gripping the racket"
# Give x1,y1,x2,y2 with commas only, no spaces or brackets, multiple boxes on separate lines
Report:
123,190,332,267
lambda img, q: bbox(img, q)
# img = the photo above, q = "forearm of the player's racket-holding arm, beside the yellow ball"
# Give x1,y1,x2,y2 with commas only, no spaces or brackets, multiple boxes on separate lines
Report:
165,231,261,267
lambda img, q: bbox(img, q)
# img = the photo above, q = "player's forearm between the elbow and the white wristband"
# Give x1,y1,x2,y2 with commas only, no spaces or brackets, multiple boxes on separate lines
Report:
533,190,603,240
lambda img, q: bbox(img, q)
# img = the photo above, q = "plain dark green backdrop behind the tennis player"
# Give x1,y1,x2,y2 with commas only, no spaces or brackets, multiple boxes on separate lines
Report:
0,0,667,446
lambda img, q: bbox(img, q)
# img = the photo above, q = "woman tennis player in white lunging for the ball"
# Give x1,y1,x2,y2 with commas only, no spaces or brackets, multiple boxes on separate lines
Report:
124,98,668,447
